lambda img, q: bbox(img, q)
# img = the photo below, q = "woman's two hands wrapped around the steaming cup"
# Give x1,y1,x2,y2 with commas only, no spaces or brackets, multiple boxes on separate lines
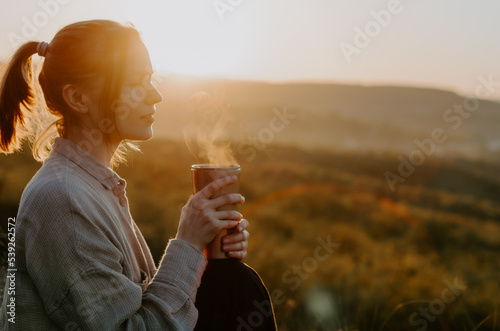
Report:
176,176,248,253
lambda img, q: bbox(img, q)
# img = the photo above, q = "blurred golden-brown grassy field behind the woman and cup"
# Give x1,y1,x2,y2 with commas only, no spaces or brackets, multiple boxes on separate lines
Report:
0,140,500,331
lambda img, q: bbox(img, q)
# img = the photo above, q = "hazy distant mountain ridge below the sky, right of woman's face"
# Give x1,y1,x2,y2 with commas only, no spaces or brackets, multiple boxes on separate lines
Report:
155,75,500,161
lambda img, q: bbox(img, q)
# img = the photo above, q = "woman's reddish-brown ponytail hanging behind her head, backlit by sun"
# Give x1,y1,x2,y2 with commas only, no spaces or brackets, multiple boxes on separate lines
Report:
0,41,38,154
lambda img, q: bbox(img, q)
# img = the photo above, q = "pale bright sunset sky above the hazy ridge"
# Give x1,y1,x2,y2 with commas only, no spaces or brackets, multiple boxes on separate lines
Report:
0,0,500,99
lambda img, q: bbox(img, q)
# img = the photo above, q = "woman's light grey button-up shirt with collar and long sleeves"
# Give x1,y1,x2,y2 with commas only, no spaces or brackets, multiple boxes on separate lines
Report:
0,137,207,331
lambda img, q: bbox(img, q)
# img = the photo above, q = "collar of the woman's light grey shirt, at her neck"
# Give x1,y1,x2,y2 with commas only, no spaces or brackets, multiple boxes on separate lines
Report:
52,137,126,190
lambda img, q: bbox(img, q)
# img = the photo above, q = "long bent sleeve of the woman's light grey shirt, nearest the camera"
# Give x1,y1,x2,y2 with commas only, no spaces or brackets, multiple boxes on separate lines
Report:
25,187,206,331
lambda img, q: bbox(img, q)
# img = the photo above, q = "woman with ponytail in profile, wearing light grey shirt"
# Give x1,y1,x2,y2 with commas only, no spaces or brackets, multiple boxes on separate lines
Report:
0,20,248,330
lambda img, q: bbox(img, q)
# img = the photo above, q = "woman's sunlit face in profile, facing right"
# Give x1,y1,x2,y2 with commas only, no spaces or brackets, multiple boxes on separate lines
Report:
111,40,162,141
